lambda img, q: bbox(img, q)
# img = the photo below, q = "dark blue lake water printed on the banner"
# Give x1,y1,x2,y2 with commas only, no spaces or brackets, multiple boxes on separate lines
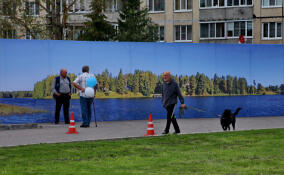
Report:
0,95,284,124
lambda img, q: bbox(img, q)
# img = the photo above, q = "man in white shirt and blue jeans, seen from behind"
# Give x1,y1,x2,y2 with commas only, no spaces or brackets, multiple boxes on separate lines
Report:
73,66,97,128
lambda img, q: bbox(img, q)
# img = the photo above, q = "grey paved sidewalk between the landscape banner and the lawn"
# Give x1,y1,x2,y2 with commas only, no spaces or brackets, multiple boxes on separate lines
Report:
0,116,284,147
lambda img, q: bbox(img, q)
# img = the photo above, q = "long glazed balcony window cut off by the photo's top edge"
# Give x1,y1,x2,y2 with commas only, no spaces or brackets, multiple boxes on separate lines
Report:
200,0,253,8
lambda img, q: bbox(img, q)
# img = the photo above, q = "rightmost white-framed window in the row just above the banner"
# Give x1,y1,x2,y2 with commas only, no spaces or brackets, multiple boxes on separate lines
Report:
262,22,282,39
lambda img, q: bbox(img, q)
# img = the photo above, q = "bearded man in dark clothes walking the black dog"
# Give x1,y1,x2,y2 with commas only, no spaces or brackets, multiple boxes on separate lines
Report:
162,71,186,134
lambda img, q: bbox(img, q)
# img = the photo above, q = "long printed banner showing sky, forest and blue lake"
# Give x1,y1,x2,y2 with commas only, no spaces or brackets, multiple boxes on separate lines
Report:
0,40,284,123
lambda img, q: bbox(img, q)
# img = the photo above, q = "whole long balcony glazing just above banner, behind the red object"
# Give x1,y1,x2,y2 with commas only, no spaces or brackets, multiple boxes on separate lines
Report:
200,21,253,39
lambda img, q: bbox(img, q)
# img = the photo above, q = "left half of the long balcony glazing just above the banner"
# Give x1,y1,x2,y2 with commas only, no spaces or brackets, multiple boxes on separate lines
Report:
200,22,225,38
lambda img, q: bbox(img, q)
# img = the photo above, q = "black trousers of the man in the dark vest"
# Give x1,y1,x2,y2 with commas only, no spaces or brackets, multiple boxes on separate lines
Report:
55,94,71,124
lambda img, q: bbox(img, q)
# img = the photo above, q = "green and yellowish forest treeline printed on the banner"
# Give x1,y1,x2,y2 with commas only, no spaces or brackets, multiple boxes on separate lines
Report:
30,69,284,98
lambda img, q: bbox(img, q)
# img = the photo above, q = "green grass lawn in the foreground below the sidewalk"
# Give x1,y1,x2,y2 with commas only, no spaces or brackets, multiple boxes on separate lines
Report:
0,129,284,175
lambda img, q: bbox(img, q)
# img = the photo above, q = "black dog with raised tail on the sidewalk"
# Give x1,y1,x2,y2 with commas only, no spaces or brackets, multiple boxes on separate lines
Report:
220,108,242,131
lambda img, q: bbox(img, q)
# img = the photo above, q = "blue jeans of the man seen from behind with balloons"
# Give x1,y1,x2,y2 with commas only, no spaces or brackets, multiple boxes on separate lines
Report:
80,97,94,125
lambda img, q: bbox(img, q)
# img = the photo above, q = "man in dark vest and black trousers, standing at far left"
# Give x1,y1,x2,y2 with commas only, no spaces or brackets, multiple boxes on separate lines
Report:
52,69,71,124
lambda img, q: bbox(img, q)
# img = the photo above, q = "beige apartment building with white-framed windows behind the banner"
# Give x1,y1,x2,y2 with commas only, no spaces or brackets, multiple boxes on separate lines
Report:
1,0,284,44
